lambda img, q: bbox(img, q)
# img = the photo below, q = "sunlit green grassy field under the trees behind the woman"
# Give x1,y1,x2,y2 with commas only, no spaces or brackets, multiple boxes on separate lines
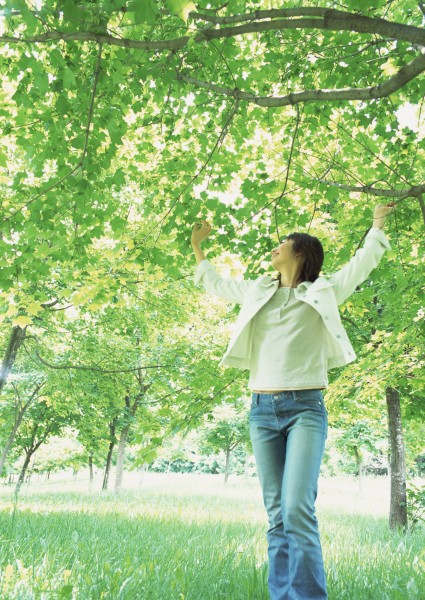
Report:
0,473,425,600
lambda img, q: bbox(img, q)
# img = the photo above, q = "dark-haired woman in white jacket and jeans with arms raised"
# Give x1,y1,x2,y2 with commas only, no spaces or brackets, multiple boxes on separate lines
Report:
191,203,393,600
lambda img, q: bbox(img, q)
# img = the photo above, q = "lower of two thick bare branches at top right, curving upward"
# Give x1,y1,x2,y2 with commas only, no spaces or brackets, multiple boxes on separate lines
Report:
177,54,425,108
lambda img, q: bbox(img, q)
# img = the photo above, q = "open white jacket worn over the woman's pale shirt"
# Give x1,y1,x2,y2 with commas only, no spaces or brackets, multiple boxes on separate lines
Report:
195,228,390,369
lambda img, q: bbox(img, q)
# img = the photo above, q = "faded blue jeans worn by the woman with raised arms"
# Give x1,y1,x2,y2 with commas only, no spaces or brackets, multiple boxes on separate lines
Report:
249,390,328,600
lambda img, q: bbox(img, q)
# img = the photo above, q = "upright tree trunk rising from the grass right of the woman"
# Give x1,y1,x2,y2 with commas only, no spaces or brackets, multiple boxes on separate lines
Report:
386,387,407,529
